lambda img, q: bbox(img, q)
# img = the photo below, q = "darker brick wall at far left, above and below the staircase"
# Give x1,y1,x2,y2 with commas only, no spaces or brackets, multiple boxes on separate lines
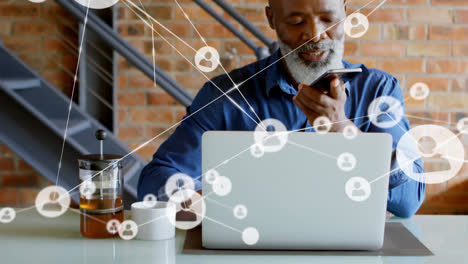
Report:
0,0,77,207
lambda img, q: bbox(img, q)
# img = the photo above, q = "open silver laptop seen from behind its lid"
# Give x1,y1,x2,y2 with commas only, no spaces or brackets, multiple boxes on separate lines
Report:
202,131,392,250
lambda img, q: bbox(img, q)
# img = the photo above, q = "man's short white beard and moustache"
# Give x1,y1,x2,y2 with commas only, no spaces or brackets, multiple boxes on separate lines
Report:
278,38,344,84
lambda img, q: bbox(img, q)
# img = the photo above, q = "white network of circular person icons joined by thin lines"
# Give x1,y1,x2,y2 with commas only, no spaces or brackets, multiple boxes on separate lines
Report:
0,0,460,248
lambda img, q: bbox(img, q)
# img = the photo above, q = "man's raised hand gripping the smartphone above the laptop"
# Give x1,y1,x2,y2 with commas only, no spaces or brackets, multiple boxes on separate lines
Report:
293,75,353,132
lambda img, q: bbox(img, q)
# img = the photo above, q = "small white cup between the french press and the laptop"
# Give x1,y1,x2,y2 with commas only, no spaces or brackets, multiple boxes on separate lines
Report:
132,201,176,240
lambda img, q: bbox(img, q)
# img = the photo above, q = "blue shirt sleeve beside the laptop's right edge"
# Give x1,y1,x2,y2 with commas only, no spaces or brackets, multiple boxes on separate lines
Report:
369,77,425,218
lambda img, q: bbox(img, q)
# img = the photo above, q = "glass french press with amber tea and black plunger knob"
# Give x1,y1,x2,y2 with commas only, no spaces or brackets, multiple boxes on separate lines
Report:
78,130,123,238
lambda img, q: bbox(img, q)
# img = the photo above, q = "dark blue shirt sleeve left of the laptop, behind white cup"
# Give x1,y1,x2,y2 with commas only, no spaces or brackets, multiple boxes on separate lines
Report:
138,83,222,201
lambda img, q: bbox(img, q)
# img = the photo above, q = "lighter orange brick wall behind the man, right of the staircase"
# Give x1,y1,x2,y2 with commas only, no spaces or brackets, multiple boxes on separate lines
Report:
0,0,468,214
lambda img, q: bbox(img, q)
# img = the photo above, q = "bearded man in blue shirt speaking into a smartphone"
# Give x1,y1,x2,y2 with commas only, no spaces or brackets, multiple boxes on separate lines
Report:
138,0,425,217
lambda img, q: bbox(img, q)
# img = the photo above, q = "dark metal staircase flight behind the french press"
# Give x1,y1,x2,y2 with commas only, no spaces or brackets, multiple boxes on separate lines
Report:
0,44,146,204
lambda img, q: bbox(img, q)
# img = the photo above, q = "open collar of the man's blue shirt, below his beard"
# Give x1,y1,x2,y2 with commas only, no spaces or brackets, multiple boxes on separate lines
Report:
265,49,362,97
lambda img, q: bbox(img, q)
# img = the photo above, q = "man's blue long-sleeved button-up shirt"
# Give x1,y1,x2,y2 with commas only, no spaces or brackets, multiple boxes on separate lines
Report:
138,51,425,217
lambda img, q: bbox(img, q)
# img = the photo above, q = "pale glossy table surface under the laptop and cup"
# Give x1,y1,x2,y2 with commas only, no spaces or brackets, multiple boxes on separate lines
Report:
0,209,468,264
